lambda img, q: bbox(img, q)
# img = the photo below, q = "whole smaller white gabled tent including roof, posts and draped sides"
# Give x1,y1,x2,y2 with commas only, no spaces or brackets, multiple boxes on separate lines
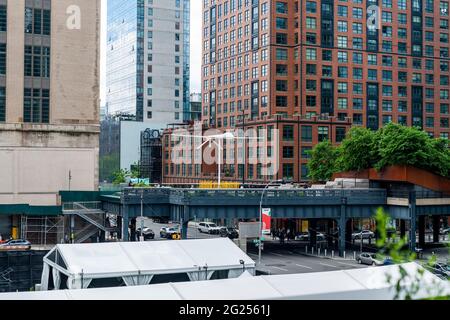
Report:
41,238,255,290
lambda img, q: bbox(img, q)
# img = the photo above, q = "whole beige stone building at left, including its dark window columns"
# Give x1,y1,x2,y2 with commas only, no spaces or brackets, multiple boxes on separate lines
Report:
0,0,100,209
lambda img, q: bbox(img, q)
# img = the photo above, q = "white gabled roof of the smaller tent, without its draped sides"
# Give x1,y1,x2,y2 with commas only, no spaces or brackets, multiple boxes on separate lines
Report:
46,238,255,278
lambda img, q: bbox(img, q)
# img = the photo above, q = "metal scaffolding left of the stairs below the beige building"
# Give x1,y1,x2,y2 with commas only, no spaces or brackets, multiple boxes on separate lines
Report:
21,216,65,248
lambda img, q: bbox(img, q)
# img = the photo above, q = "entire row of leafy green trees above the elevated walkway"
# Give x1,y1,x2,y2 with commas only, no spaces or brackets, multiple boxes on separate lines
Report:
308,123,450,181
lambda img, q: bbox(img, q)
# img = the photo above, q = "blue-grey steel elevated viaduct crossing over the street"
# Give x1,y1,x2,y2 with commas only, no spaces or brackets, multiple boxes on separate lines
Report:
97,188,450,253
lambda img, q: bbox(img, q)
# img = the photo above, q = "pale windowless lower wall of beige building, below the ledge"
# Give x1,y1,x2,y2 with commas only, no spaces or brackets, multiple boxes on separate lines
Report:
0,125,98,205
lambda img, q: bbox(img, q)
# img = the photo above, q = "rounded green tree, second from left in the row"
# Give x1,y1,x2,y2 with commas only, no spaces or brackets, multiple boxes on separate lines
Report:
336,127,378,171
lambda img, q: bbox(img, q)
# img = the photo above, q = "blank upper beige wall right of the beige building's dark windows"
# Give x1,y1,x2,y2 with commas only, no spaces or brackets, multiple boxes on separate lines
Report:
51,0,100,124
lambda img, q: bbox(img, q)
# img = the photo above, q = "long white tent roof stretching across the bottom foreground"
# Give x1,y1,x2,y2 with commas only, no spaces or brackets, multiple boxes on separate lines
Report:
0,263,450,300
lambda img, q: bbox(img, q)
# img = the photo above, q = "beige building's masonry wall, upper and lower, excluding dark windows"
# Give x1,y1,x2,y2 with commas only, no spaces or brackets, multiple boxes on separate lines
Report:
0,0,100,205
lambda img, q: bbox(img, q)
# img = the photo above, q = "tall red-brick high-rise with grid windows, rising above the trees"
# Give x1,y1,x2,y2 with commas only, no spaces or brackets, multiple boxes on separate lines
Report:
163,0,450,182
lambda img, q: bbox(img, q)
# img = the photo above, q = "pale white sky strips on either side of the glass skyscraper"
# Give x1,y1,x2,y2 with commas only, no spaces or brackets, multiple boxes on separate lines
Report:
100,0,202,105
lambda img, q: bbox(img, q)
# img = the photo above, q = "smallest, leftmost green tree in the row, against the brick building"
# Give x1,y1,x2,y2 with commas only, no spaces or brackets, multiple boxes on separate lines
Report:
308,140,339,182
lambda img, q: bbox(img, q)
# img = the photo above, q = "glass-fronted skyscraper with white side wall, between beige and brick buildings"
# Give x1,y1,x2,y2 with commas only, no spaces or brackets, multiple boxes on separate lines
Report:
107,0,190,126
